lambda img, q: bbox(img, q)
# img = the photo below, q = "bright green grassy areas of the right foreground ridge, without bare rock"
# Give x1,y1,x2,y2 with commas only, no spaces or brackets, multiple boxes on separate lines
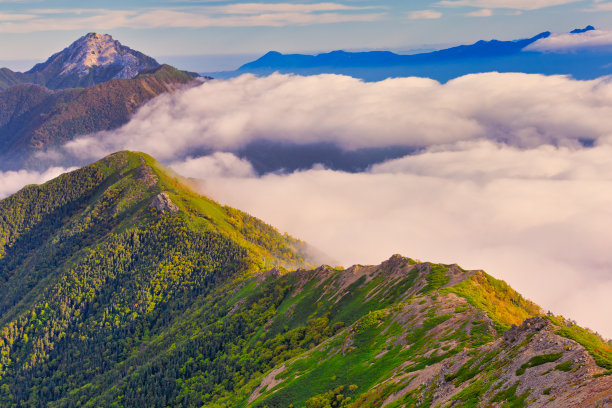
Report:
207,259,606,407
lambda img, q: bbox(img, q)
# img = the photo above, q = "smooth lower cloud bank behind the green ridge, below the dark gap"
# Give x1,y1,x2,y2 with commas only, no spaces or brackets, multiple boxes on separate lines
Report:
178,142,612,337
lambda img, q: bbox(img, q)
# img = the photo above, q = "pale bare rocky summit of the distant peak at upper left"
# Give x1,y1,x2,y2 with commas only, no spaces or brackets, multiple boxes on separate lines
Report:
26,33,159,88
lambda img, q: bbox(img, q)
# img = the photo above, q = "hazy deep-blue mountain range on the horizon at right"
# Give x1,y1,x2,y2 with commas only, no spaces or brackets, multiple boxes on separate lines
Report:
212,26,612,82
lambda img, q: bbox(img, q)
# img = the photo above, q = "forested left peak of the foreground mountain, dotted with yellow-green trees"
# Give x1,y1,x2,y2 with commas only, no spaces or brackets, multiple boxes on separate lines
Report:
0,152,304,406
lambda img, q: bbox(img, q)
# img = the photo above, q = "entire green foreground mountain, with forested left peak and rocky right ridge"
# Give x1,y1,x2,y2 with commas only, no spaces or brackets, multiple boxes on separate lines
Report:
0,152,612,408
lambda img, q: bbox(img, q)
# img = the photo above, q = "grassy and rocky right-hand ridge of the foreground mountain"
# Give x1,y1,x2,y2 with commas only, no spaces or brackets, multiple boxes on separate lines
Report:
218,256,612,407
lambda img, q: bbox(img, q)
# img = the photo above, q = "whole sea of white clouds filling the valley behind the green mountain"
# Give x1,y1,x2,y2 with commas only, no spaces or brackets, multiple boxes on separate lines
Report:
0,73,612,338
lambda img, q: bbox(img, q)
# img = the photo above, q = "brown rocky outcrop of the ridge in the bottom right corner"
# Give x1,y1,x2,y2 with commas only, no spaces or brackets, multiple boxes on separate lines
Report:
382,310,612,408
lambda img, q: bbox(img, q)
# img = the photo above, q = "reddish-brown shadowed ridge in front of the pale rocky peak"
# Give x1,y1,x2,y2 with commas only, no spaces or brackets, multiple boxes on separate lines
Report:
0,65,193,170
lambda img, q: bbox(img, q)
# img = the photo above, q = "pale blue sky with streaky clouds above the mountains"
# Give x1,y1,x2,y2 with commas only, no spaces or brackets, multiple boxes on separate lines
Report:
0,0,612,68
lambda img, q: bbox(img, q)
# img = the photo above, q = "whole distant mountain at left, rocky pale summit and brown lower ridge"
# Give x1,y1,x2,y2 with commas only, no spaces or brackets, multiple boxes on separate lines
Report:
0,33,199,170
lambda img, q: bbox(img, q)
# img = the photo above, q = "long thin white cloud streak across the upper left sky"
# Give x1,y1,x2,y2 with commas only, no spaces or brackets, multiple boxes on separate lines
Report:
0,3,384,33
